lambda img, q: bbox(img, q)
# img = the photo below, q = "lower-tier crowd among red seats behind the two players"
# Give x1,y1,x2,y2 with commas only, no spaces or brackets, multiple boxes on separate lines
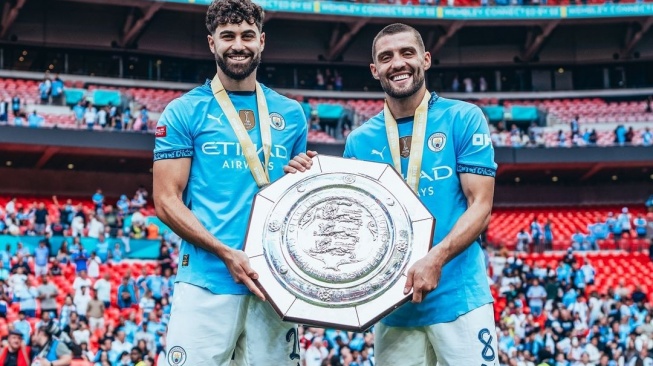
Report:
0,188,653,366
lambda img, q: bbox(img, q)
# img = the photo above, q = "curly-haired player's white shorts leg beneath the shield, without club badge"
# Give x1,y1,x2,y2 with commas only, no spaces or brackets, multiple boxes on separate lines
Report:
232,298,300,366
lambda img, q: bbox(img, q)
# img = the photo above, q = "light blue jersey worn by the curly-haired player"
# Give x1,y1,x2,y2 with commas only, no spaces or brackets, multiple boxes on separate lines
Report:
154,81,307,294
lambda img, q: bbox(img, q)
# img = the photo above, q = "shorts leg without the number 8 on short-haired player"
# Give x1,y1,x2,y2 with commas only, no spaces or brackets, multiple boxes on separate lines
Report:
374,323,437,366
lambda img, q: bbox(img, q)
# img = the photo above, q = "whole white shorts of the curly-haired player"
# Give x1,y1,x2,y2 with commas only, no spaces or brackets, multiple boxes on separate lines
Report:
159,282,299,366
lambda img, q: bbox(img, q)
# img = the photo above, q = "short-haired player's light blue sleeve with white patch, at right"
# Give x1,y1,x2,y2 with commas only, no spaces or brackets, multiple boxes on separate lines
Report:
456,106,497,177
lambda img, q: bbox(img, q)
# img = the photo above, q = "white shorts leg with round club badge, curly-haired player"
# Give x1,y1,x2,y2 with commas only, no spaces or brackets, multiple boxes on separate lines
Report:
165,282,247,366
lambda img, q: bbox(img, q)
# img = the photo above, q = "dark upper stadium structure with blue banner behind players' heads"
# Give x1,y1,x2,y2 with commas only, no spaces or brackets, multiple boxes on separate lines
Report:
0,0,653,65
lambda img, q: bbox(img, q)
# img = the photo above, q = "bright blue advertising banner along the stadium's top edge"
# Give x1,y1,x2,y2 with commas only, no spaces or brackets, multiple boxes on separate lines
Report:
157,0,653,20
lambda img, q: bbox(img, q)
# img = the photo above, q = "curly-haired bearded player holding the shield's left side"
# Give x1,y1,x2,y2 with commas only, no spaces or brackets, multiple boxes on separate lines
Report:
153,0,314,366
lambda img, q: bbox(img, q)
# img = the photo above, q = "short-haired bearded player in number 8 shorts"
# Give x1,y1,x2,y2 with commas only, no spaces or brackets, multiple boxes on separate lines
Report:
296,24,499,366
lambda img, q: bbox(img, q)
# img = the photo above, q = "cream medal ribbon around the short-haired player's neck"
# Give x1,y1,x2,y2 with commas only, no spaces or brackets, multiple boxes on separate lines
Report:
383,90,431,193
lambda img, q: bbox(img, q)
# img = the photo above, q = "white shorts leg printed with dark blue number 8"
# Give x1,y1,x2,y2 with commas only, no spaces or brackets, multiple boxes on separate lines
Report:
427,303,499,366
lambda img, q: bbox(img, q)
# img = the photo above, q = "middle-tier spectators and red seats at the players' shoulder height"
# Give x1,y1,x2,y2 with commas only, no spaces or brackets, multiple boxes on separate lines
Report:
0,73,653,148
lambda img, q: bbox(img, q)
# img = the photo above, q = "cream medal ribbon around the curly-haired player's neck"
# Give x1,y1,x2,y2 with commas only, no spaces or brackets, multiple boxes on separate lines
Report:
211,74,272,188
